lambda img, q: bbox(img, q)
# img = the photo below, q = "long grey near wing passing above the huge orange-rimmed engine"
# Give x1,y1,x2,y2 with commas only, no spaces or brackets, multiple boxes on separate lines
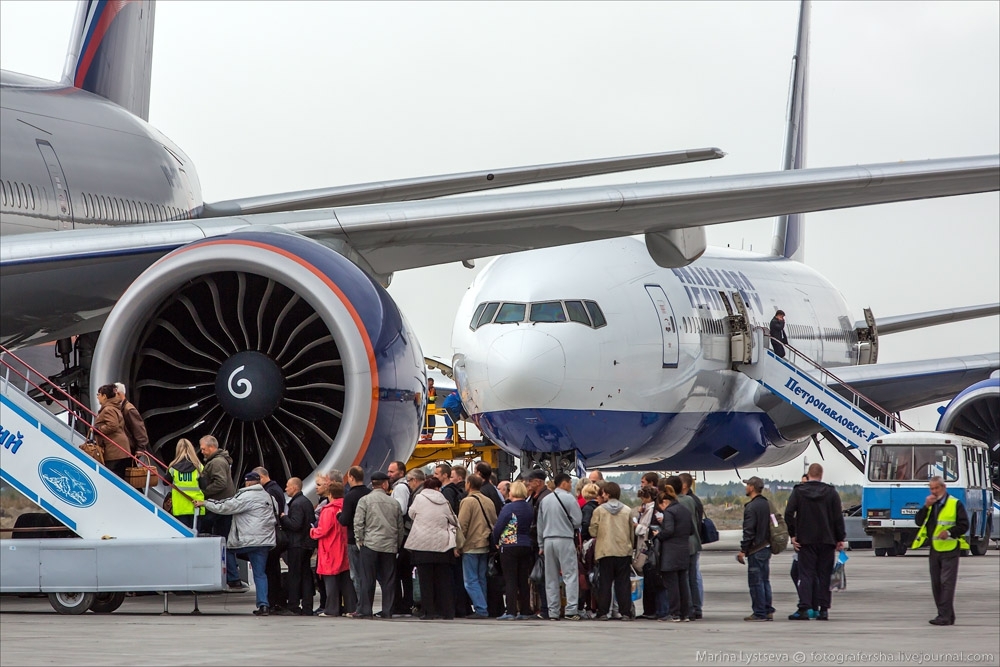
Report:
0,155,1000,341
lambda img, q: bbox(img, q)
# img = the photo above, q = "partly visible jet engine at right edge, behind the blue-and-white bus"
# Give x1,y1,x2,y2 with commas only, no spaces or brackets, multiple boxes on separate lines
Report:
937,372,1000,485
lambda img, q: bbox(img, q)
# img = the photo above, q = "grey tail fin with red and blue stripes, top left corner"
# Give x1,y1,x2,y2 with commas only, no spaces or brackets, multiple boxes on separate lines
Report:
63,0,155,120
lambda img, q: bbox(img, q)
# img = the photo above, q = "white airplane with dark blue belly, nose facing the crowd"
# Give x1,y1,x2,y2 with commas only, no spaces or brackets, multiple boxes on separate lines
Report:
452,2,1000,480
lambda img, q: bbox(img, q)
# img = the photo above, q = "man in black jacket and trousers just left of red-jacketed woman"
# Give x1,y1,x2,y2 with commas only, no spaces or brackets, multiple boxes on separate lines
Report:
280,477,316,616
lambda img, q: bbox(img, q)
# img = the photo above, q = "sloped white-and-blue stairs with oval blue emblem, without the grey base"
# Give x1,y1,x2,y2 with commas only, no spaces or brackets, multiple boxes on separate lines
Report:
0,346,195,540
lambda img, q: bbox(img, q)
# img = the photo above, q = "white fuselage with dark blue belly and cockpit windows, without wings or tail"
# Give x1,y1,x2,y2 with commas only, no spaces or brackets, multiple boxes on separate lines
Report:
453,238,857,470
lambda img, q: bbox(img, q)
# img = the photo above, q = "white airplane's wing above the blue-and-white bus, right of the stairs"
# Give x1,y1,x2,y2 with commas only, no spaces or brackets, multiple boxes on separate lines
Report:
831,352,1000,412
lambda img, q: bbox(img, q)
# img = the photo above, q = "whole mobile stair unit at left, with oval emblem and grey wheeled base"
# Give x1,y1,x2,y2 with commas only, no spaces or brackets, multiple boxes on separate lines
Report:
0,347,226,614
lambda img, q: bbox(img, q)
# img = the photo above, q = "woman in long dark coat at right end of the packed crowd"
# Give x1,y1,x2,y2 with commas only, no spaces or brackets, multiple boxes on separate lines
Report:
656,482,694,623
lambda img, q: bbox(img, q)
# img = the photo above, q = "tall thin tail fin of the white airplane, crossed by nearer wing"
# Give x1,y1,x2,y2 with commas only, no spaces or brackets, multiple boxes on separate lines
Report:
771,0,810,262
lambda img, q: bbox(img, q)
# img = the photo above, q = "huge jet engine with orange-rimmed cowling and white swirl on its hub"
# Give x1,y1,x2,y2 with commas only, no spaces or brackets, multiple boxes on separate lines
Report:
91,230,426,492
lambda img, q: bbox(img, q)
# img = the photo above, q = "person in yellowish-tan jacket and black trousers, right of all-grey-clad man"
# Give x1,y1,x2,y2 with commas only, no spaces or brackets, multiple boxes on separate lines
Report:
590,482,635,621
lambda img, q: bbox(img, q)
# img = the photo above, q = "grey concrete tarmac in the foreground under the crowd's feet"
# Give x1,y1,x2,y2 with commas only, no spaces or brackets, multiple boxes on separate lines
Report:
0,536,1000,667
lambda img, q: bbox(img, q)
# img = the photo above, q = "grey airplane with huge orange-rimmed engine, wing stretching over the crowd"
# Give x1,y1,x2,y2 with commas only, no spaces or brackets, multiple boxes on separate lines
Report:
0,1,1000,492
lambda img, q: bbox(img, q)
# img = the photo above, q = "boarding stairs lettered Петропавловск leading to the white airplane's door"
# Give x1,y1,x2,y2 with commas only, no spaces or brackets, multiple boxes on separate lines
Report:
730,294,913,469
